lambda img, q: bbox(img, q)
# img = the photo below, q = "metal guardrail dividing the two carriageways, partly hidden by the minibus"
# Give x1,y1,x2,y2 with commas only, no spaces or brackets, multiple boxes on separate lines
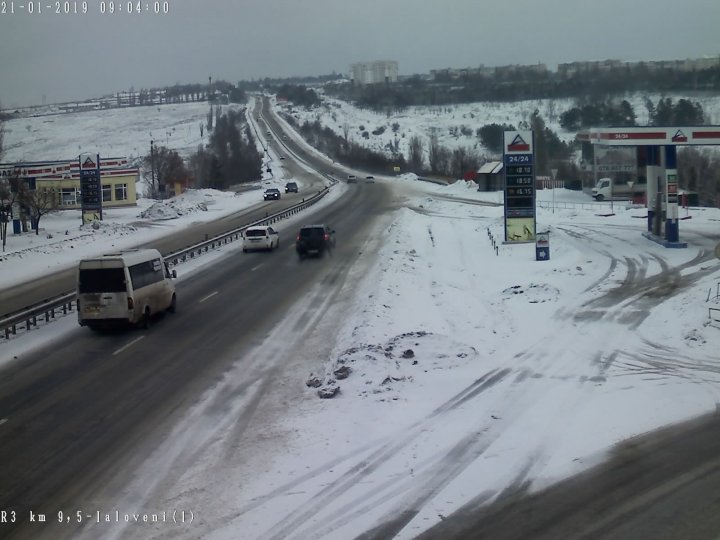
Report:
0,186,336,339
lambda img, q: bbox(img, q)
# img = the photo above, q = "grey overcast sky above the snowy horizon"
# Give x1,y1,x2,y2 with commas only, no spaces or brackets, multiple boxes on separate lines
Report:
0,0,720,107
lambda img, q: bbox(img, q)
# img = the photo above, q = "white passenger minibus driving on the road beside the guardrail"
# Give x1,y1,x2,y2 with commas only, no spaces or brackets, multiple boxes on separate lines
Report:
77,249,177,328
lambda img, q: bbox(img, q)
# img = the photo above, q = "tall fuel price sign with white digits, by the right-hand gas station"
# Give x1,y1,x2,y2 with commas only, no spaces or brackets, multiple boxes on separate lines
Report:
503,131,536,244
